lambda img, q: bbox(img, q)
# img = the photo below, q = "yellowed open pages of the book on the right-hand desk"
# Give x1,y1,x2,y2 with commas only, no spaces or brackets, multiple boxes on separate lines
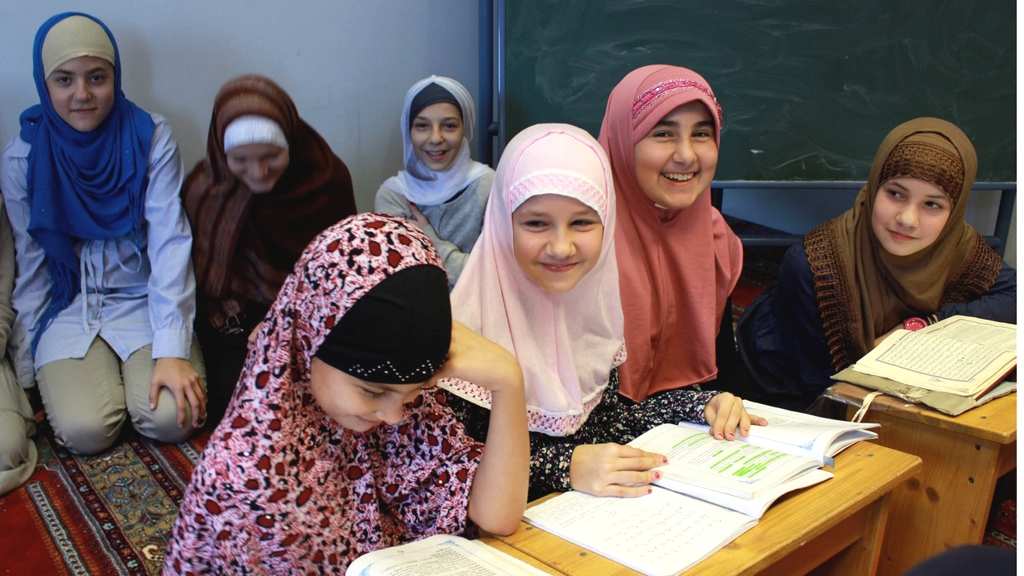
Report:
853,316,1017,397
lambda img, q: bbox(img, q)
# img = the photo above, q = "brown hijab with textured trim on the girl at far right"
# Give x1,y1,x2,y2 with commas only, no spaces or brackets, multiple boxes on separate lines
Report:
804,118,1001,370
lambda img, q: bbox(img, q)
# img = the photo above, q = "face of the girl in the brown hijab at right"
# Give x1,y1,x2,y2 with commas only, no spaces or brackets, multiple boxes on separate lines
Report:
871,177,952,256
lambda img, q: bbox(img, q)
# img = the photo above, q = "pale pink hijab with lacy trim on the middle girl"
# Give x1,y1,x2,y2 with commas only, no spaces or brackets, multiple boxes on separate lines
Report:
442,124,623,436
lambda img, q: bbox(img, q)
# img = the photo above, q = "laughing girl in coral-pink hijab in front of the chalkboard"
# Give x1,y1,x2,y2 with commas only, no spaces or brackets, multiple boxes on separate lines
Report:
598,66,745,402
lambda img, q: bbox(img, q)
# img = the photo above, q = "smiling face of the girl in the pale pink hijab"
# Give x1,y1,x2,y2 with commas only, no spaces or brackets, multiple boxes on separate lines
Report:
512,194,604,294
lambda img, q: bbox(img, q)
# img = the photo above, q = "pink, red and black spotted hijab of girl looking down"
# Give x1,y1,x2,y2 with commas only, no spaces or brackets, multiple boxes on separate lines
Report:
164,214,482,574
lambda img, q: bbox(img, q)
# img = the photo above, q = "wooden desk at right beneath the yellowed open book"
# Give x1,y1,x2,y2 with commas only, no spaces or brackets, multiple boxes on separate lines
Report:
829,382,1017,575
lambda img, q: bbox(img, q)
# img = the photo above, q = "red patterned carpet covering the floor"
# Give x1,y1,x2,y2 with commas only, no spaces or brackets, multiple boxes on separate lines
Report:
0,221,1017,576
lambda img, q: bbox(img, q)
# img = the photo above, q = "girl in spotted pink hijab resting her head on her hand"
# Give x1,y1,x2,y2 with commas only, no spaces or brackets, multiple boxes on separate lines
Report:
164,214,529,574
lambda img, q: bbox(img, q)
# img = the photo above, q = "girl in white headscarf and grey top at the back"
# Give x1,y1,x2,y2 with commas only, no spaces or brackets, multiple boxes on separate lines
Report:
374,76,495,286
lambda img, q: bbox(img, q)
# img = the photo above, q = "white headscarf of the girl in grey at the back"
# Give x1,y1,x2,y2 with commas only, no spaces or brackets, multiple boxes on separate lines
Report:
384,76,489,206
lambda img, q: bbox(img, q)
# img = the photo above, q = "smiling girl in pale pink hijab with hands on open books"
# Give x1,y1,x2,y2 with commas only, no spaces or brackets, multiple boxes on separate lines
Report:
441,124,760,497
